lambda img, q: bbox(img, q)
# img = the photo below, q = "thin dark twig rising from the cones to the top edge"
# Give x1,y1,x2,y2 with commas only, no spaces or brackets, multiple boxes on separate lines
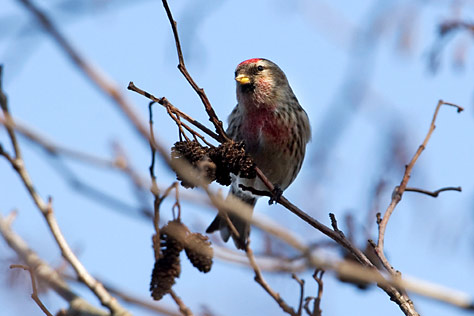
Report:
163,0,231,142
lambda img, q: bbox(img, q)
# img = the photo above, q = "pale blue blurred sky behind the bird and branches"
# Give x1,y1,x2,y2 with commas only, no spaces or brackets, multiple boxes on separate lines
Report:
0,0,474,316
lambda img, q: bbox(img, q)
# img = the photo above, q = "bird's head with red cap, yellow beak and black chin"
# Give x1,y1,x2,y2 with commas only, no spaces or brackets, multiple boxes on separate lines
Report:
235,58,291,107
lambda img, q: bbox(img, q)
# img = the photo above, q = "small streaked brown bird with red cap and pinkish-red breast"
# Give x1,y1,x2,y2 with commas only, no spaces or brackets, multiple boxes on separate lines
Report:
206,58,311,249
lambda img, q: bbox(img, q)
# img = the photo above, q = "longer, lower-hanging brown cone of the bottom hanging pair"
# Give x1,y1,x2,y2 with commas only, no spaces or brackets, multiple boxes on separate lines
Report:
150,221,186,300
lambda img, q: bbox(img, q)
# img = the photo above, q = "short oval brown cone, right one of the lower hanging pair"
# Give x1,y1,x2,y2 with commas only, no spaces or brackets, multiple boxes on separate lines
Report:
184,233,214,273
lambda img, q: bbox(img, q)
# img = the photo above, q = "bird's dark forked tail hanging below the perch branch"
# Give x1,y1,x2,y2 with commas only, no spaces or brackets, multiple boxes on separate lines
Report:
206,186,257,249
